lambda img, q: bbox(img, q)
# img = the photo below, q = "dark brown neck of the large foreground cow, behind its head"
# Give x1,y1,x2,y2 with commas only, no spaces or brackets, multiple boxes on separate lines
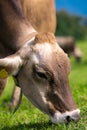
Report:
0,0,36,55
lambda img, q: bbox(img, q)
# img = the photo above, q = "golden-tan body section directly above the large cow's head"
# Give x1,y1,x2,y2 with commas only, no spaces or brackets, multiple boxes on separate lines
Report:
22,0,56,33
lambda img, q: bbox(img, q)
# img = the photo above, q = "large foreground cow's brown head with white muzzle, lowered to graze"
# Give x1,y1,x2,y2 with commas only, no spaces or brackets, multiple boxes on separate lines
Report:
0,33,80,123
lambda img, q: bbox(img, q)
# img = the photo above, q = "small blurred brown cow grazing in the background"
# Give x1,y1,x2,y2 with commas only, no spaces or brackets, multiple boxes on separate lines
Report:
56,37,82,61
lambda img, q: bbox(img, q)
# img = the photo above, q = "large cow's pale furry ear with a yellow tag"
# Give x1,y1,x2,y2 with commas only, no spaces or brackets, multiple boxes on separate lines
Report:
0,54,23,78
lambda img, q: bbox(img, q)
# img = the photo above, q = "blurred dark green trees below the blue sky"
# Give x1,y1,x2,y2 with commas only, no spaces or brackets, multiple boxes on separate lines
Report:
56,11,87,39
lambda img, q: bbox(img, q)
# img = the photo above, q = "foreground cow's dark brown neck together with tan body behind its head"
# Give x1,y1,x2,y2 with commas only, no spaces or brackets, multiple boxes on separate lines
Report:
0,0,56,56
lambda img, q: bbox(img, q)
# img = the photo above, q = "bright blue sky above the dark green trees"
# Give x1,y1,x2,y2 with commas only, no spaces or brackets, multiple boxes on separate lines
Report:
56,0,87,17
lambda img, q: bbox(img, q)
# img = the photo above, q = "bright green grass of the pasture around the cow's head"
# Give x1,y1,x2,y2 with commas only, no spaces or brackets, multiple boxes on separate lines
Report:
0,41,87,130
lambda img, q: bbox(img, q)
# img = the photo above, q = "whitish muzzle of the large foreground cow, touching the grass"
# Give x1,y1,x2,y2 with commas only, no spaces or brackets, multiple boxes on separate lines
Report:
50,109,80,124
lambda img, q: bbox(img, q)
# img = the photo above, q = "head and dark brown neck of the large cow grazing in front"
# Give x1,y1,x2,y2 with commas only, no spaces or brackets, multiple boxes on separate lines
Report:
0,0,80,123
